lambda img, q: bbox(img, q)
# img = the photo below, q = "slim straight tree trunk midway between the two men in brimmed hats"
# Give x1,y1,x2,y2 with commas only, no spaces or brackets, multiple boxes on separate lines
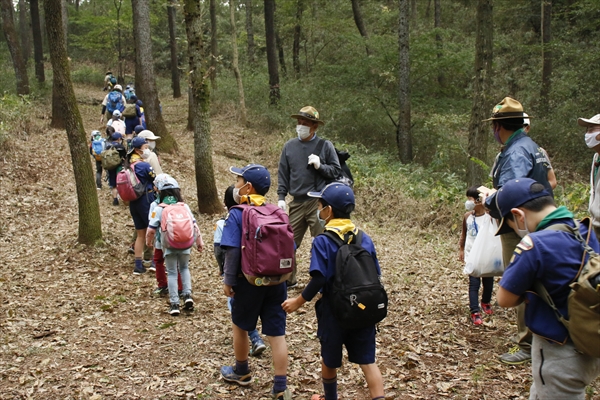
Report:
396,0,412,164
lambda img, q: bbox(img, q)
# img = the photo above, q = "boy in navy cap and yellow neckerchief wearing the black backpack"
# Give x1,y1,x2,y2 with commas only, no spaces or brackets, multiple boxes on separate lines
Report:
282,183,385,400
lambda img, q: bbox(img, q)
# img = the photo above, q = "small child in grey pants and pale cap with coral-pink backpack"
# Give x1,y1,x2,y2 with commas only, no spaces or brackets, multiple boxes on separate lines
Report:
145,176,204,316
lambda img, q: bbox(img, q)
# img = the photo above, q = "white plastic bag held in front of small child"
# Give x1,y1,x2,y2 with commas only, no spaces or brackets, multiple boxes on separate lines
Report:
463,215,504,278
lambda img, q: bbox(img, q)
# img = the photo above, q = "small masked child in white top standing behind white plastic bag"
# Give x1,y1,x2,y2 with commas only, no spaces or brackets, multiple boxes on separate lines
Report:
458,186,494,326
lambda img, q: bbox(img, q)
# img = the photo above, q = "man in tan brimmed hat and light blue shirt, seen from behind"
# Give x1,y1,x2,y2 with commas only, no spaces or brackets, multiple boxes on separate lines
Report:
484,97,552,365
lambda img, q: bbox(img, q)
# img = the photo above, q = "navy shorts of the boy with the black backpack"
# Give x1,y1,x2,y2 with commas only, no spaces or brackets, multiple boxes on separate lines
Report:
315,299,375,368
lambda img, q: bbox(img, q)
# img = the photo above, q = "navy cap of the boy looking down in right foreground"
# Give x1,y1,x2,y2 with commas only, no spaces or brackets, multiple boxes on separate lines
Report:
494,178,552,235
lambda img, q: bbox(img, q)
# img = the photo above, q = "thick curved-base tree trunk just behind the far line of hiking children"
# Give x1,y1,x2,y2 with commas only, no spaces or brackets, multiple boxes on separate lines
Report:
131,0,177,152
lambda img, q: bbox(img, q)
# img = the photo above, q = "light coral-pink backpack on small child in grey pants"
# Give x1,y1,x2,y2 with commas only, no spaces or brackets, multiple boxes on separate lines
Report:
158,202,196,250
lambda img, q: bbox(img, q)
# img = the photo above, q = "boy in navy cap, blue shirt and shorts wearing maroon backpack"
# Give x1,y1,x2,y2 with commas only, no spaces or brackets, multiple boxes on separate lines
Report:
221,164,291,400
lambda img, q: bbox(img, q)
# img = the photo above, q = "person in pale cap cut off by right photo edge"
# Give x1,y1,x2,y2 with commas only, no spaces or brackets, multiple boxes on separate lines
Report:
577,114,600,240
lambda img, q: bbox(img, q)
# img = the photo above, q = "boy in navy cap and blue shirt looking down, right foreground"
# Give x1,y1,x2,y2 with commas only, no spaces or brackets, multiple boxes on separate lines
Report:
494,178,600,400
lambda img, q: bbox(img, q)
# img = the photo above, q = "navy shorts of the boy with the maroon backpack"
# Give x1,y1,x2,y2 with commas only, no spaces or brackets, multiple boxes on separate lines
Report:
231,276,287,336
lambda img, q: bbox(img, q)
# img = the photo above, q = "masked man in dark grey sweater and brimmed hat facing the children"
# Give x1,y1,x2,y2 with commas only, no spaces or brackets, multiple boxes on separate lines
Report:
277,106,342,287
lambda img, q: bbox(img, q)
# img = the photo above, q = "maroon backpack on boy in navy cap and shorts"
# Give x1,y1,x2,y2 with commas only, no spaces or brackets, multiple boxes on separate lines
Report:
235,204,294,286
